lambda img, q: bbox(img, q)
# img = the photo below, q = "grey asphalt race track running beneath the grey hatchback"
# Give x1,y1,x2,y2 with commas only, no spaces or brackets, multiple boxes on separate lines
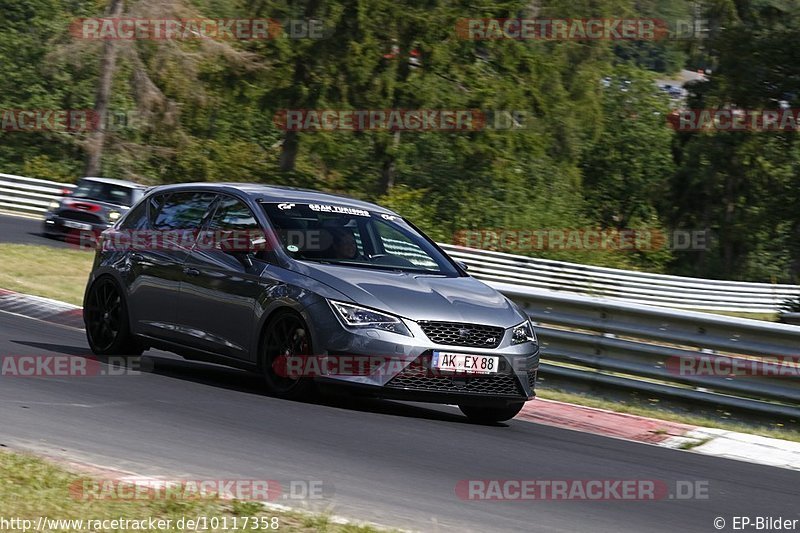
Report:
0,213,800,532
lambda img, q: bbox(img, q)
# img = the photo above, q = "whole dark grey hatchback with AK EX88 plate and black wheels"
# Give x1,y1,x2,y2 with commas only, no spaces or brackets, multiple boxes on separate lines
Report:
84,183,539,423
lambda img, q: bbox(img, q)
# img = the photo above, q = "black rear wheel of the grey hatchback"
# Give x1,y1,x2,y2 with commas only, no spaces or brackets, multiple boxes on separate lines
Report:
83,276,144,356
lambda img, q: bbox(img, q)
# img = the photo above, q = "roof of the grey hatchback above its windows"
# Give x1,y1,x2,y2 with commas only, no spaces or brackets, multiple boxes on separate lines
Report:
145,182,394,213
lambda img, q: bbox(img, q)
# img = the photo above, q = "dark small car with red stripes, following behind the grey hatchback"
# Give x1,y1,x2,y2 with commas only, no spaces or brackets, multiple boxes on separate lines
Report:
42,178,145,238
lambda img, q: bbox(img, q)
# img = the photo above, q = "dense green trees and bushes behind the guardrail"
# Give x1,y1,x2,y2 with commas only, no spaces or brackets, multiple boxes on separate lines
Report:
0,0,800,282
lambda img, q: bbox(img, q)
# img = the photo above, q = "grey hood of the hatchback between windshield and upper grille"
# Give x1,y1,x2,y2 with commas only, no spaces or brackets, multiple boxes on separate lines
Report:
291,261,525,328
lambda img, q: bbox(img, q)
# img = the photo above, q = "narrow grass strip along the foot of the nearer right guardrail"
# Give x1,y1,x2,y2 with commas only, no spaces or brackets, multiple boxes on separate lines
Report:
536,387,800,442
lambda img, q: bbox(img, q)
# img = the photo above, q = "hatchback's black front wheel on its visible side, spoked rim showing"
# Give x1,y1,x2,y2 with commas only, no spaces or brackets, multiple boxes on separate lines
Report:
260,310,315,400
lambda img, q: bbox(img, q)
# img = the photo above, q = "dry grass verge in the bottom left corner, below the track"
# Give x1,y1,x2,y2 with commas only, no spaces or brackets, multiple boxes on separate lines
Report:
0,451,378,533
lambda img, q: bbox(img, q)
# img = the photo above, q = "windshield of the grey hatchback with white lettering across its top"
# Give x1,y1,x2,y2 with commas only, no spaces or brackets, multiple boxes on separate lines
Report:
262,203,459,277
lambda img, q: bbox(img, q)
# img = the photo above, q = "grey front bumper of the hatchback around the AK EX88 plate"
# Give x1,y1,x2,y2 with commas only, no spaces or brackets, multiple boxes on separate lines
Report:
305,302,539,405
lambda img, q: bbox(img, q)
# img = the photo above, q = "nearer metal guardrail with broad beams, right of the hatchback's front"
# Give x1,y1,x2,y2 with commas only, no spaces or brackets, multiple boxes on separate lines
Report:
489,282,800,420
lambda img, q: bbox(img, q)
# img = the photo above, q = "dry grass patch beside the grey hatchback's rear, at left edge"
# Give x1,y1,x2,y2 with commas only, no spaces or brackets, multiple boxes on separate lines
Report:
0,243,94,305
